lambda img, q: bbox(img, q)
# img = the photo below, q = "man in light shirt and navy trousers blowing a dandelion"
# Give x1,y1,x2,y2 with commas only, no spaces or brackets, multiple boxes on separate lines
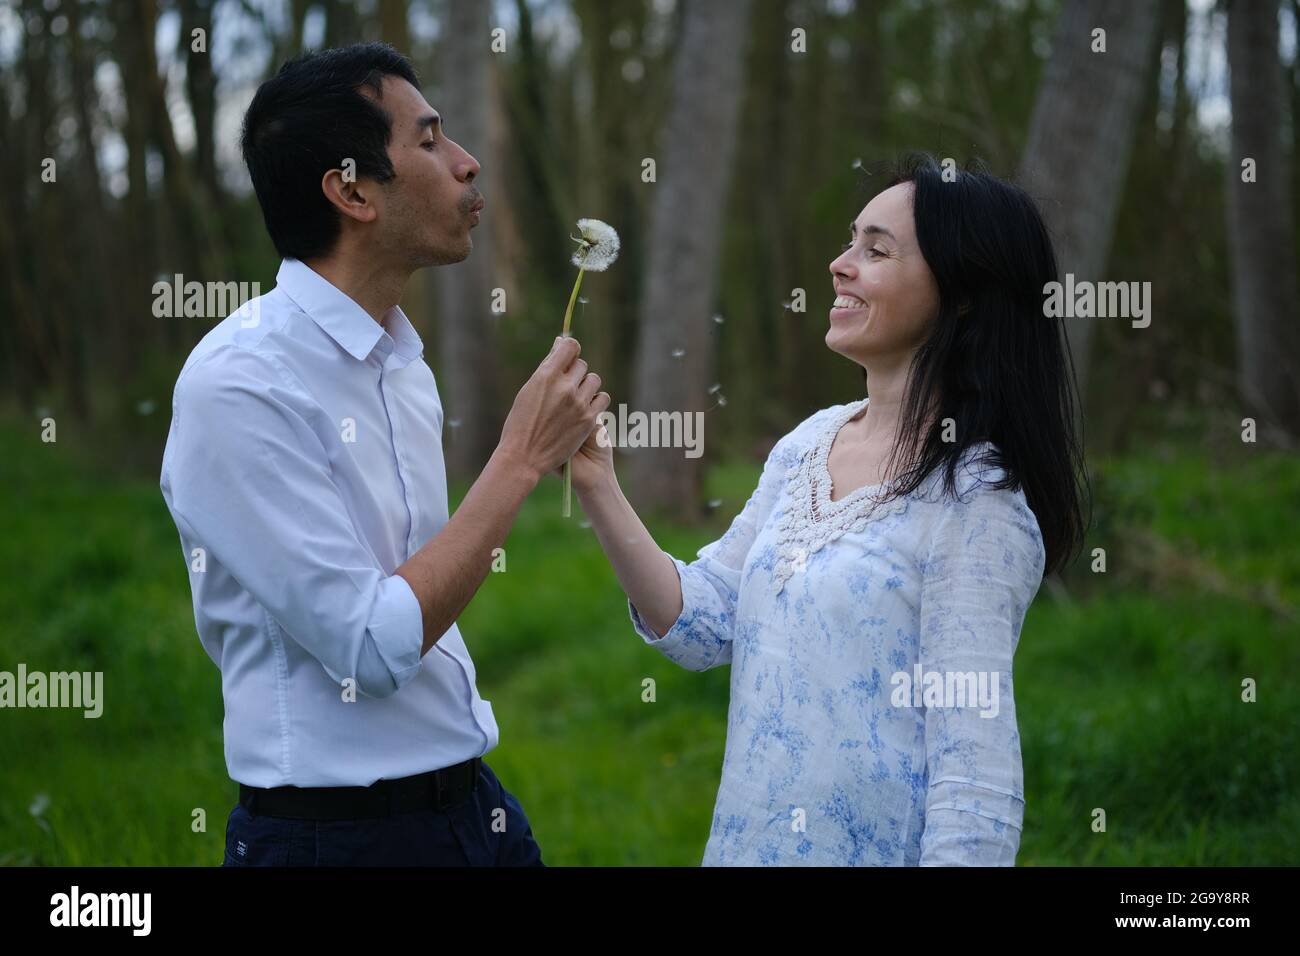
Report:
161,44,610,866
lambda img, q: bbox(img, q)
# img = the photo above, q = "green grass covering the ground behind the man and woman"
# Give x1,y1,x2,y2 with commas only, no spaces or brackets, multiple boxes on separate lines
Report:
0,425,1300,865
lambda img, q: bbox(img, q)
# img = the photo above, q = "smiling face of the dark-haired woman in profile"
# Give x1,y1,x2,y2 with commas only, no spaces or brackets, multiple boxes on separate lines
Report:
826,182,939,367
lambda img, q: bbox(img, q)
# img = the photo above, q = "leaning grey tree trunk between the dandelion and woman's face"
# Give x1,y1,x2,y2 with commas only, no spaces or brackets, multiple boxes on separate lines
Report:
629,0,750,519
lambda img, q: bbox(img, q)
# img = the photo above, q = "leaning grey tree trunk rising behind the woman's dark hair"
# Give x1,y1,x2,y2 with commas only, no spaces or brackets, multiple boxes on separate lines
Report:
1021,0,1160,395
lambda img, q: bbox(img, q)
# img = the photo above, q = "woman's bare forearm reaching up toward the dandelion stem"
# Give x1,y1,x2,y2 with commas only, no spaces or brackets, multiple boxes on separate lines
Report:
577,472,681,637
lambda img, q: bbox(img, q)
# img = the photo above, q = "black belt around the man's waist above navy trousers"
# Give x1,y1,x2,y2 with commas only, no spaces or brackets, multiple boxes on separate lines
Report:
239,757,482,819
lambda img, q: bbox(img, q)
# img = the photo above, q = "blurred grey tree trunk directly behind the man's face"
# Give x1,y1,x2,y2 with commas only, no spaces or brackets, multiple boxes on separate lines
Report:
434,0,501,479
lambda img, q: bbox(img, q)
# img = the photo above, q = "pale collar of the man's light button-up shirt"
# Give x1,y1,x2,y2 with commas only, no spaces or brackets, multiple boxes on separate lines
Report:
276,259,424,365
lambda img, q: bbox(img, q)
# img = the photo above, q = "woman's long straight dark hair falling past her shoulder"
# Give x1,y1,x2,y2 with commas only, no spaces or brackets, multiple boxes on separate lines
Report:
887,153,1087,574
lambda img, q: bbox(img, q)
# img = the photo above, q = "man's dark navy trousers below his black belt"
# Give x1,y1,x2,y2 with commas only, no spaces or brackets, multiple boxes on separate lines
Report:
221,762,545,866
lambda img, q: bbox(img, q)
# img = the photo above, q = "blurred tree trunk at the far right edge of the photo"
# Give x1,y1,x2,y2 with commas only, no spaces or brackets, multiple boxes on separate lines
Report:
1227,0,1300,438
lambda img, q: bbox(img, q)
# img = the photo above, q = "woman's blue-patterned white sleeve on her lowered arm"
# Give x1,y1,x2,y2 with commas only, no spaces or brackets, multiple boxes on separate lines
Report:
920,476,1044,866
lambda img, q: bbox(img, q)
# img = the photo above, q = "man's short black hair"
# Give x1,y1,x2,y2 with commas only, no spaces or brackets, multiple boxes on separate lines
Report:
241,43,420,259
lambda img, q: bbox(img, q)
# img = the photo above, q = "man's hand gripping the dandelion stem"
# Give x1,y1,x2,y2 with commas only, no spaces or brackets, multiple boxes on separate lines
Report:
498,337,610,481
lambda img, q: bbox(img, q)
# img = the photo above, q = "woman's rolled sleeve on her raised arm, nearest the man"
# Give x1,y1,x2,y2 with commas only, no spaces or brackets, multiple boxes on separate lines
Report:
628,415,816,671
